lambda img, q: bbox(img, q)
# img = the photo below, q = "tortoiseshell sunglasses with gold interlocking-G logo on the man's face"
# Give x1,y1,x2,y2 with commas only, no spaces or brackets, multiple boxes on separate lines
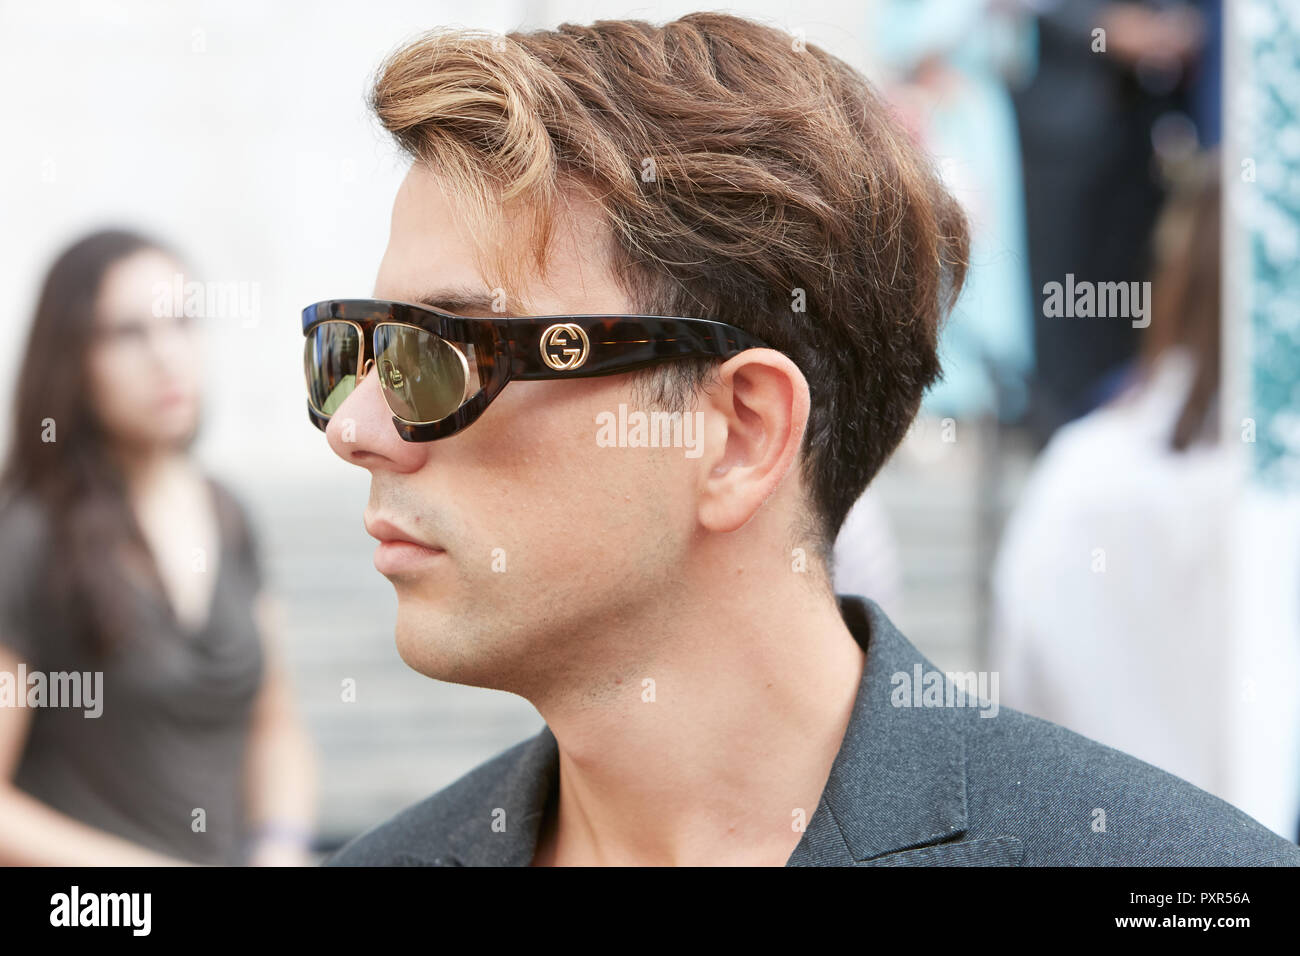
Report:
303,299,768,441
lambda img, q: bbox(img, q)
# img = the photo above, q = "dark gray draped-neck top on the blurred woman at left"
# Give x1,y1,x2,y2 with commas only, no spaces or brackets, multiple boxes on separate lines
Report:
0,479,263,865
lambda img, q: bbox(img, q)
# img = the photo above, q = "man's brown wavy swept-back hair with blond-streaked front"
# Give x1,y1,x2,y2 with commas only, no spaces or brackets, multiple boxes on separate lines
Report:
369,13,969,555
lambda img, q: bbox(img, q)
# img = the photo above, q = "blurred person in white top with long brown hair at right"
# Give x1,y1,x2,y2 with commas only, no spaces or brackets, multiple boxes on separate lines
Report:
992,152,1274,816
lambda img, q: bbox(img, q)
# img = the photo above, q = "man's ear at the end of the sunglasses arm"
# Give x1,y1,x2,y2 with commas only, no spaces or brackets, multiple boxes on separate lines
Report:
699,349,810,532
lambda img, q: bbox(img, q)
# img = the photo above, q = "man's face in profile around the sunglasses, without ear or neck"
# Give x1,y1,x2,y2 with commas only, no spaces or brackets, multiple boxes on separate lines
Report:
326,164,709,700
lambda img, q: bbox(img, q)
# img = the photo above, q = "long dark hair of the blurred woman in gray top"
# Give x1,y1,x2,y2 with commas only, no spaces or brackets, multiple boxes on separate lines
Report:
0,229,189,653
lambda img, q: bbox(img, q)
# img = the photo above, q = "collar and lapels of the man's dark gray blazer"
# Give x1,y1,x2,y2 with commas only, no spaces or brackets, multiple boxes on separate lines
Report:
431,596,967,866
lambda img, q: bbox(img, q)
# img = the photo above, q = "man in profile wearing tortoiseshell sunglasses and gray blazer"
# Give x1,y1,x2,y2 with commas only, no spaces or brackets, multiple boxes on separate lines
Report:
314,13,1300,865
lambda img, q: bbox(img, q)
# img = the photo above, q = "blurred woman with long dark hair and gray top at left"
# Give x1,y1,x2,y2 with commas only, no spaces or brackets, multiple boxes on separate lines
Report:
0,230,315,865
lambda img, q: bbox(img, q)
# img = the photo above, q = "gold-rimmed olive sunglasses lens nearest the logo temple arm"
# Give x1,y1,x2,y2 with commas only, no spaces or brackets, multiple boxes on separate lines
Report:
374,325,469,424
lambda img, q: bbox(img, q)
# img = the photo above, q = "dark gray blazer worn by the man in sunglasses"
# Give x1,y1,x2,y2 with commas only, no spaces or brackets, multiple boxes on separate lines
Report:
325,597,1300,866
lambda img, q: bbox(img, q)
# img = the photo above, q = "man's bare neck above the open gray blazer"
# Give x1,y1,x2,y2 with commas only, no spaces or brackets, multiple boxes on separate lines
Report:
522,574,865,866
